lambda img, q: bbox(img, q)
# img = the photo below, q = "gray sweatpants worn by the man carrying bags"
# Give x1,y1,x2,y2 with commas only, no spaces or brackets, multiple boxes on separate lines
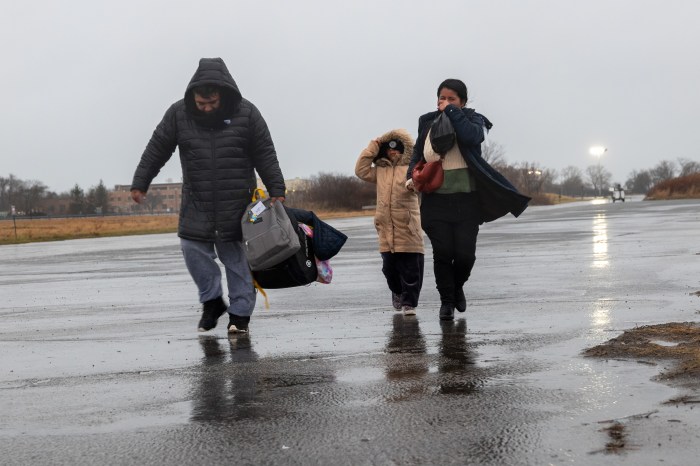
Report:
180,238,255,316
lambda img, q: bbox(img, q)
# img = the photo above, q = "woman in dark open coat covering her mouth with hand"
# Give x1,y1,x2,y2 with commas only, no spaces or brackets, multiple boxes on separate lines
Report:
406,79,530,320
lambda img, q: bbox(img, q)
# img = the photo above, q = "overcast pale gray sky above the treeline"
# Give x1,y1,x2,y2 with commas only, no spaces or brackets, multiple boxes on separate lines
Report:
0,0,700,192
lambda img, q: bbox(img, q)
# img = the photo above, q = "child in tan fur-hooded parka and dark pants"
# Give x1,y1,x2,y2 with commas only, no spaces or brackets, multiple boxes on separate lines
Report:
355,129,424,315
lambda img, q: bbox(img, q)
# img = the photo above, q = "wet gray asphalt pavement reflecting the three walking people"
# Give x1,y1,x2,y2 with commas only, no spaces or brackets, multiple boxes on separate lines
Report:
0,199,700,465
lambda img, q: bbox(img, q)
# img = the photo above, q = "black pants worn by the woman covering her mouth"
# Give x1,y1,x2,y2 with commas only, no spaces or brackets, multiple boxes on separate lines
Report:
420,192,481,305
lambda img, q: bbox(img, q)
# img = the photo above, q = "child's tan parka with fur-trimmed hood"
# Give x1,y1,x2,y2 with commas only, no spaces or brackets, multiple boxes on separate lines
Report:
355,129,424,254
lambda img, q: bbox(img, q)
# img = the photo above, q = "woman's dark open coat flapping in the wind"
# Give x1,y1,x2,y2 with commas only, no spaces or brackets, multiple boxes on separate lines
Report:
405,105,530,222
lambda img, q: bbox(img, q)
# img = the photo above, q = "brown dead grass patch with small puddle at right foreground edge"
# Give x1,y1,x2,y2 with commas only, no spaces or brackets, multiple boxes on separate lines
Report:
584,322,700,387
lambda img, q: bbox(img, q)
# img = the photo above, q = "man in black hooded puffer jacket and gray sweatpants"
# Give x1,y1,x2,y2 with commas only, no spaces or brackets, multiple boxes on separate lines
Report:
131,58,286,333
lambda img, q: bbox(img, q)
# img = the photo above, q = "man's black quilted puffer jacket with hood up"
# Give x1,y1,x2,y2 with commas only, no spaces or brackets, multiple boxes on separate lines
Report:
131,58,286,241
